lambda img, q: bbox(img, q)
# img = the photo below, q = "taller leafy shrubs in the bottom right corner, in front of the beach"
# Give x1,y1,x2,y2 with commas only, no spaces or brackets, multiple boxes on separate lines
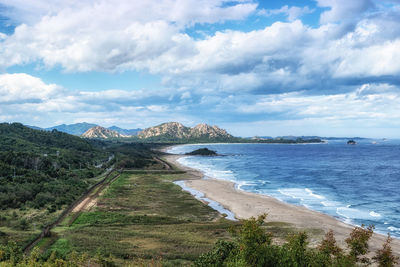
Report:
194,215,398,267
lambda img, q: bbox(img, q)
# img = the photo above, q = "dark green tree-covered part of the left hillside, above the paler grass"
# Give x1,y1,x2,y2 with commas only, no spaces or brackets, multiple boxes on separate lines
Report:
0,123,108,210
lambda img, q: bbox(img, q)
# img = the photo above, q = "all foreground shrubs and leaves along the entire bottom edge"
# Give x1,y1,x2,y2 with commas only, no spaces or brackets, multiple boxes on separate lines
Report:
0,216,398,267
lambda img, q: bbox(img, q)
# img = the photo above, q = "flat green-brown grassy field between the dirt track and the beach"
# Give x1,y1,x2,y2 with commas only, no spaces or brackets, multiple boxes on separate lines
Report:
42,173,239,266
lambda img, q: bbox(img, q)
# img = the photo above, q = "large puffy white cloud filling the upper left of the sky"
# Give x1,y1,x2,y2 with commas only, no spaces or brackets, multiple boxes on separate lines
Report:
0,0,257,71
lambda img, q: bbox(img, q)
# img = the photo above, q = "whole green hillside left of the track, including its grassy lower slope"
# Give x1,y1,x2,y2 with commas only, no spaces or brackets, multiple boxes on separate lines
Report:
0,123,111,247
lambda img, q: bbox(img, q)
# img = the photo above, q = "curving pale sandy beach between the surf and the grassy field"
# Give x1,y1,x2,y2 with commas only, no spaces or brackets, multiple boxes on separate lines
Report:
165,155,400,256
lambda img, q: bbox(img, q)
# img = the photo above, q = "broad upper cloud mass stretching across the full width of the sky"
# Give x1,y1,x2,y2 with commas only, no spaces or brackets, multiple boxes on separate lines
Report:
0,0,400,96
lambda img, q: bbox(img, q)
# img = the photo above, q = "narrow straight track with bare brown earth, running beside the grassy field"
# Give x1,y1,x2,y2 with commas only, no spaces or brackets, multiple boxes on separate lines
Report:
23,167,122,254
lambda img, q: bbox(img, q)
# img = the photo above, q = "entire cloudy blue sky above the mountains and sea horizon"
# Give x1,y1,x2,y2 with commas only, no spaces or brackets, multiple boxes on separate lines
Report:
0,0,400,138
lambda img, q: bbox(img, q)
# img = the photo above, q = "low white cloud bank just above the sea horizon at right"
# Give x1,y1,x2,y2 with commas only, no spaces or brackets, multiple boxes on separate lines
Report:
237,84,400,122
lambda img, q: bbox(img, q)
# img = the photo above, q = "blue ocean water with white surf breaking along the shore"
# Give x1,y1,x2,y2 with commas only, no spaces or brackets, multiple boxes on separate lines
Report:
169,140,400,238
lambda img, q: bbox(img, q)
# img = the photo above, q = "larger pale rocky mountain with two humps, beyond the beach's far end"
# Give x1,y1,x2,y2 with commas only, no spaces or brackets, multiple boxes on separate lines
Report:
138,122,234,142
